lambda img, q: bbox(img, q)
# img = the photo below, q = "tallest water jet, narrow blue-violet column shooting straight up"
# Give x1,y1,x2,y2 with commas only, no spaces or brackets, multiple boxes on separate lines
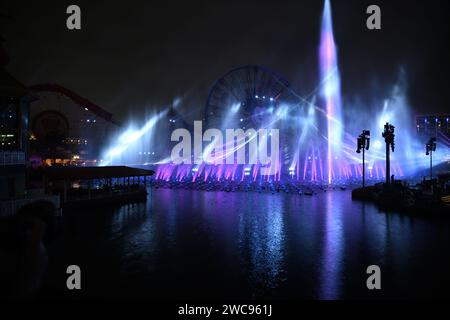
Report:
319,0,343,184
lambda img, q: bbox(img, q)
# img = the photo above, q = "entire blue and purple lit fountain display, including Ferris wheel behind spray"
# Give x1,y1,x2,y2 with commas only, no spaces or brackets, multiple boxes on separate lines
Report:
99,0,450,193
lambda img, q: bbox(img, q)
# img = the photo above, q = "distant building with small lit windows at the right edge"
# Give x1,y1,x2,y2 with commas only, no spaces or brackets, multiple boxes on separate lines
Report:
416,114,450,138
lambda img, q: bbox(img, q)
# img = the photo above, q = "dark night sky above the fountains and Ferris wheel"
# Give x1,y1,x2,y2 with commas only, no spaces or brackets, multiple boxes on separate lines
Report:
0,0,450,119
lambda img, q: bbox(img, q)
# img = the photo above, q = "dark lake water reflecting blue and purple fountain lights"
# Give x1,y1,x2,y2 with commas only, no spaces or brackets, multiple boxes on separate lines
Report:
43,189,450,299
